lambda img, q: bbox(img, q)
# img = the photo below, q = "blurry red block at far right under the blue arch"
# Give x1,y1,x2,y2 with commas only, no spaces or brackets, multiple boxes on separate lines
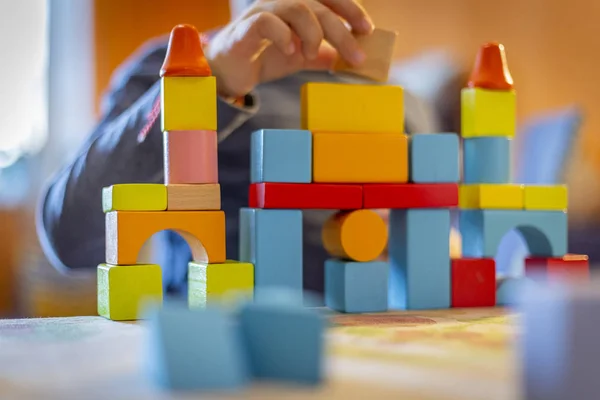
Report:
525,254,590,283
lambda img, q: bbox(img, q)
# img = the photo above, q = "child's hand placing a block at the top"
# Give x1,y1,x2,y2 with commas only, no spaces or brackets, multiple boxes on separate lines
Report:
206,0,373,97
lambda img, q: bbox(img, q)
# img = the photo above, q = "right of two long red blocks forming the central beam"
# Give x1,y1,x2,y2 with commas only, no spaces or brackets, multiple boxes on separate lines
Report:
363,183,458,208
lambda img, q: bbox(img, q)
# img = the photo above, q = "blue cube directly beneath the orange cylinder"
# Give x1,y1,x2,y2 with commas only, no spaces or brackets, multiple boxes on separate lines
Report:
325,259,389,313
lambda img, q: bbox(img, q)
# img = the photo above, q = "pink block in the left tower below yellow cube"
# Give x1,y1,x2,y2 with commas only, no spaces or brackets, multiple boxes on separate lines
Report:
163,131,219,185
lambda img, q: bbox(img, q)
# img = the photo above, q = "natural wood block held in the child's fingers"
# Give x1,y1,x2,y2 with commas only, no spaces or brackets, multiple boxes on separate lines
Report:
333,28,398,82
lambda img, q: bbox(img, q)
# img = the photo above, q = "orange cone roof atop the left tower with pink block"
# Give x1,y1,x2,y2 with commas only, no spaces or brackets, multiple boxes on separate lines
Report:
160,25,212,77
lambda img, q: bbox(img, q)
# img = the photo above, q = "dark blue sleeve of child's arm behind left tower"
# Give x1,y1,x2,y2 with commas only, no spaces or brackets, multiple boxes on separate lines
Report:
36,41,254,272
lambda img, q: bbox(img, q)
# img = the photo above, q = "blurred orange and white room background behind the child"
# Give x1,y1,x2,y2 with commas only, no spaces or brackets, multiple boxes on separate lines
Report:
0,0,600,317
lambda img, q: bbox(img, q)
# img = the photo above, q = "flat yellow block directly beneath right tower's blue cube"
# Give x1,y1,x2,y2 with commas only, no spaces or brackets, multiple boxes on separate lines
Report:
458,183,523,210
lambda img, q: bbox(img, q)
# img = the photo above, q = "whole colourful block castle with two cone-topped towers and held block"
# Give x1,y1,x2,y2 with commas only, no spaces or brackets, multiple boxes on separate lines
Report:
98,25,587,320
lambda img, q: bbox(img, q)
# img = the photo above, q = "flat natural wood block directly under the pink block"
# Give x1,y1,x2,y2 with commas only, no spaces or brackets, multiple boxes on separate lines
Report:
166,183,221,211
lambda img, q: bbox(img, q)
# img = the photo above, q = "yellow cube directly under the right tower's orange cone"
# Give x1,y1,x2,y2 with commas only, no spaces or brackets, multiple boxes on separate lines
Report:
461,88,517,138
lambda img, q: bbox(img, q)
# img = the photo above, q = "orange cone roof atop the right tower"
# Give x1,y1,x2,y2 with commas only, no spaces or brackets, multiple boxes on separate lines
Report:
467,42,513,90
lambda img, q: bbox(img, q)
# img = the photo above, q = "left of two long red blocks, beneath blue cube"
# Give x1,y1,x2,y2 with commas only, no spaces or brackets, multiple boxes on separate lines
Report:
249,183,363,210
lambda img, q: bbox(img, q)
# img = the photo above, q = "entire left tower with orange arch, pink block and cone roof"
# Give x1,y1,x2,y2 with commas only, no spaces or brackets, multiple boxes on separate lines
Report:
98,25,254,320
